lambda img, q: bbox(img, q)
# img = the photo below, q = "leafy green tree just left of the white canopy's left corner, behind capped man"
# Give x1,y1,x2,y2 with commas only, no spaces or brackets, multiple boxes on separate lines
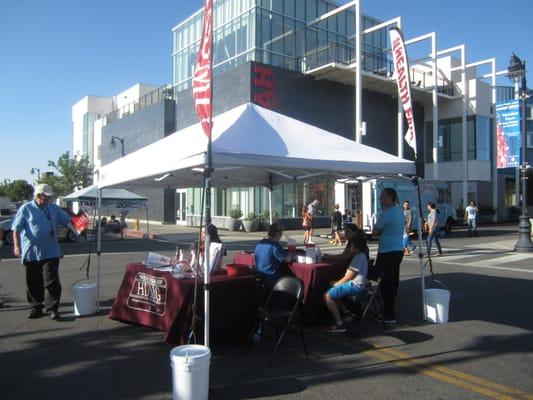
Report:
46,151,93,196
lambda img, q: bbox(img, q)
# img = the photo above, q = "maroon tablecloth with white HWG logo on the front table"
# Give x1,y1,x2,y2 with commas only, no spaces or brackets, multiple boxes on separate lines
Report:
109,263,257,345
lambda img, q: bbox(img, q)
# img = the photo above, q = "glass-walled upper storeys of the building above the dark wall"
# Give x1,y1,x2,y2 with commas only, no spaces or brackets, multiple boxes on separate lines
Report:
172,0,388,91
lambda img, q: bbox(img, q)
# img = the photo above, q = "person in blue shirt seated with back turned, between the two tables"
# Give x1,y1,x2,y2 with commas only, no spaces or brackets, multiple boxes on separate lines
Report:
255,224,290,289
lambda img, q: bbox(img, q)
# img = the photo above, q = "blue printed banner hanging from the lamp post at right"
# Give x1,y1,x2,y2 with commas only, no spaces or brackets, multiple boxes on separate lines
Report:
496,100,521,168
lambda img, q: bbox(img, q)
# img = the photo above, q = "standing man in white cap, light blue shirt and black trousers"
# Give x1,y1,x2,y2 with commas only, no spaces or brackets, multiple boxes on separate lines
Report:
11,184,75,320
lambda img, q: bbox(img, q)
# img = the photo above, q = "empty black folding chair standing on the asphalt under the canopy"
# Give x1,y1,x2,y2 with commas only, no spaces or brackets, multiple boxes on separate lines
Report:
246,276,308,367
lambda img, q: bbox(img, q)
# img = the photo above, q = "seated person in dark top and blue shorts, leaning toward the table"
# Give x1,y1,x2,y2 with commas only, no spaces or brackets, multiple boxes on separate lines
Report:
324,229,368,333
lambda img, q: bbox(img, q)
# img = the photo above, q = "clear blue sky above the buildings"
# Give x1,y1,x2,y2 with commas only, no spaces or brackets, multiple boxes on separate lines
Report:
0,0,533,181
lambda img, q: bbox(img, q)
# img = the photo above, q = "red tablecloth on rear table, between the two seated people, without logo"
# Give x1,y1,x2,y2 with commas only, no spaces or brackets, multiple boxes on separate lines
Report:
289,262,347,322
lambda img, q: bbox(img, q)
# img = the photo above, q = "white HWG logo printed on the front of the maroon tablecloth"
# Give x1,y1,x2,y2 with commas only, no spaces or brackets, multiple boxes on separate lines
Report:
127,272,168,316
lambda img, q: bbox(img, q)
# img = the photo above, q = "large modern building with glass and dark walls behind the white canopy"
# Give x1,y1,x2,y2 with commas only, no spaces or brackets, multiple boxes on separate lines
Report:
77,0,505,223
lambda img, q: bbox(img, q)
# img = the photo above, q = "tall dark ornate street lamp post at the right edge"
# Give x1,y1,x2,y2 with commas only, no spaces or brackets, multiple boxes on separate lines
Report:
507,53,533,253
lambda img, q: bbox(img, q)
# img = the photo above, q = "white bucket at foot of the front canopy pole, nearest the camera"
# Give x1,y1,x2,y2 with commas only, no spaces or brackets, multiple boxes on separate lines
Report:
170,344,211,400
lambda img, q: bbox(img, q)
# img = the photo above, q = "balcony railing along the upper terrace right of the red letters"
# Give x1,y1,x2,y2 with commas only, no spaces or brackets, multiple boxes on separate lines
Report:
298,42,455,96
